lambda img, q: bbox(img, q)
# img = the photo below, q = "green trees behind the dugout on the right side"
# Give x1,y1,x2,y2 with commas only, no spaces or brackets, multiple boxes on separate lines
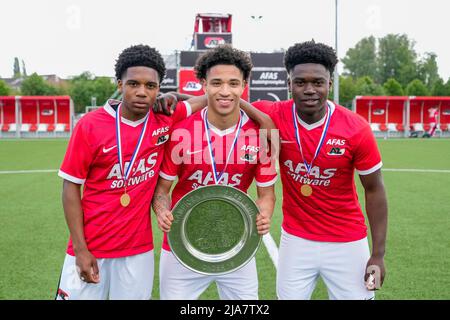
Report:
339,34,450,107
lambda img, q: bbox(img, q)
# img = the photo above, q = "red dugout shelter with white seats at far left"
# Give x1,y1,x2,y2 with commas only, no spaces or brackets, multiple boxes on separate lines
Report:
0,96,74,138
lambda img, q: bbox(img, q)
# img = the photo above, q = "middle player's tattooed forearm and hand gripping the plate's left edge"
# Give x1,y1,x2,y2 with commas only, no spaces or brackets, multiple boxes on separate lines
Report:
152,177,173,232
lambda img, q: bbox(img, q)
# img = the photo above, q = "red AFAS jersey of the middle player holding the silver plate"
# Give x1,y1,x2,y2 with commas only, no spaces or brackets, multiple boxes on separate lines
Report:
160,108,277,250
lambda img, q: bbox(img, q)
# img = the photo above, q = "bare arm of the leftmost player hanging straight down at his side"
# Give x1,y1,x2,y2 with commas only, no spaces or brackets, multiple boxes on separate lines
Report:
62,179,100,283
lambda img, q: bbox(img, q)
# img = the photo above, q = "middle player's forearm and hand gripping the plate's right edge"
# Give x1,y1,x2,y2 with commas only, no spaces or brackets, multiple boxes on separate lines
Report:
256,184,276,235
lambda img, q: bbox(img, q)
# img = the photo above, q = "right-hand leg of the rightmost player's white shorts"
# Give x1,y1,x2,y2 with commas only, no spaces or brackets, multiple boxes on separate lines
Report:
320,238,374,300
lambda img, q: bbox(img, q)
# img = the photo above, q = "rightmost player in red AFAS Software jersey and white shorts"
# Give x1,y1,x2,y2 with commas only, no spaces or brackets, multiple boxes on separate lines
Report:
254,41,387,299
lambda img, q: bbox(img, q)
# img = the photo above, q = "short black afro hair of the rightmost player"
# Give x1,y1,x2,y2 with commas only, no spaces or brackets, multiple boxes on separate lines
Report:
284,40,338,75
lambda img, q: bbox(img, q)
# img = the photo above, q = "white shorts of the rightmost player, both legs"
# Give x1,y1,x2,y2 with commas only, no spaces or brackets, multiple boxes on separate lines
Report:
277,230,374,300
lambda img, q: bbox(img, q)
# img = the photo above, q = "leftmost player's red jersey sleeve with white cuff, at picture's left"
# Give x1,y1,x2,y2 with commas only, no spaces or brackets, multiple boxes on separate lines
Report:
58,120,94,184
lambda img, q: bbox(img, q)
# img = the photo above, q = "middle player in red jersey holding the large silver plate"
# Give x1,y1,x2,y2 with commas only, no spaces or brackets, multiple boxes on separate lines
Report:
153,46,276,300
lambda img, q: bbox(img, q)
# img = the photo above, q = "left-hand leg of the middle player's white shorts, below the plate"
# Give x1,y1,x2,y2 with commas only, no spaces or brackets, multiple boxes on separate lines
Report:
159,249,213,300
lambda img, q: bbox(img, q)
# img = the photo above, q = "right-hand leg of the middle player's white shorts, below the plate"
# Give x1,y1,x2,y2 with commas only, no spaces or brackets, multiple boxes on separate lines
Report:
216,258,258,300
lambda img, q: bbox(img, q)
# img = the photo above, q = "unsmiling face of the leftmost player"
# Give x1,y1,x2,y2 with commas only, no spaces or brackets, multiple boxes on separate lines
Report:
117,67,159,121
